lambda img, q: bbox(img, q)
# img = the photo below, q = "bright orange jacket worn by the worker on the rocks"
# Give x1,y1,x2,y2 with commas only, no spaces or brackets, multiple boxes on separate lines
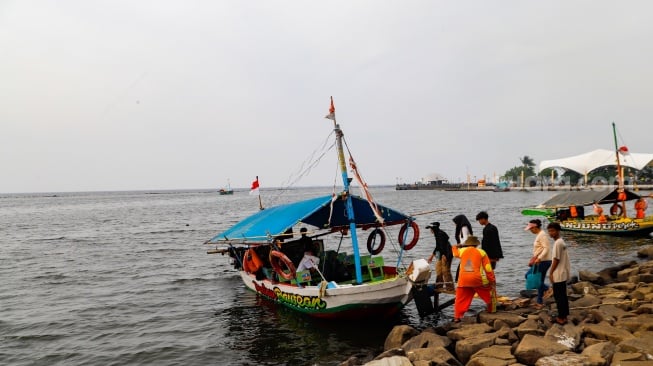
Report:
452,246,496,287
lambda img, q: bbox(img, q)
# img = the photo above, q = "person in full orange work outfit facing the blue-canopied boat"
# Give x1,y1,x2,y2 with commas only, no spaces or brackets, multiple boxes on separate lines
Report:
453,236,496,322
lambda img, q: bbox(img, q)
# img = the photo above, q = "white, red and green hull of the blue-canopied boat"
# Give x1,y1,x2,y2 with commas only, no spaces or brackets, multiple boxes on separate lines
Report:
239,271,412,320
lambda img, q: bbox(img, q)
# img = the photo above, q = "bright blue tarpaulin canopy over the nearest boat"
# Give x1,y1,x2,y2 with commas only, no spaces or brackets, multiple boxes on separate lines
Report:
209,195,412,243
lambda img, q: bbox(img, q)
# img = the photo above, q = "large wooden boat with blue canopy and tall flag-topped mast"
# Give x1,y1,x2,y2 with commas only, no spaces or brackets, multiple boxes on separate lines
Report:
207,99,431,320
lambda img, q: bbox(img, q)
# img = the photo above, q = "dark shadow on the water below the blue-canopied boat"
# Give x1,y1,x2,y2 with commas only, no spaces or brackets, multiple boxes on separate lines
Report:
214,287,394,365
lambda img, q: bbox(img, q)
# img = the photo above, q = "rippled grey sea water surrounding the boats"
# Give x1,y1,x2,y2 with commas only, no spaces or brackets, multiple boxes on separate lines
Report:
0,188,651,365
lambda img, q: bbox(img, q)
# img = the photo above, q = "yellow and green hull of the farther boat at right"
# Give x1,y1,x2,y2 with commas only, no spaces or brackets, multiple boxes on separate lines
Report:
558,216,653,236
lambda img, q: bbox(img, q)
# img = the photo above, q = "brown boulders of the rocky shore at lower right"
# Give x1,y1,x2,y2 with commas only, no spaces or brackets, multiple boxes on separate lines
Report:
341,246,653,366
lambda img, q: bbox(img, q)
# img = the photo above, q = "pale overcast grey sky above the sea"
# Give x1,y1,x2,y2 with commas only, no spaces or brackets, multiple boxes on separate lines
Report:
0,0,653,193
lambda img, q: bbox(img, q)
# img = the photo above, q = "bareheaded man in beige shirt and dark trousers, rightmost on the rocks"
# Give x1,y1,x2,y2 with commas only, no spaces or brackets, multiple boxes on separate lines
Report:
546,222,571,325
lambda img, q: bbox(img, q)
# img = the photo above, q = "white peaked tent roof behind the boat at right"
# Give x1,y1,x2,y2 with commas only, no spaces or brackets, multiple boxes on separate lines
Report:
540,149,653,179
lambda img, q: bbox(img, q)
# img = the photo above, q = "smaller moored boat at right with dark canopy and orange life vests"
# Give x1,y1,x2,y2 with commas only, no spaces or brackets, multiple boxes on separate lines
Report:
522,123,653,236
